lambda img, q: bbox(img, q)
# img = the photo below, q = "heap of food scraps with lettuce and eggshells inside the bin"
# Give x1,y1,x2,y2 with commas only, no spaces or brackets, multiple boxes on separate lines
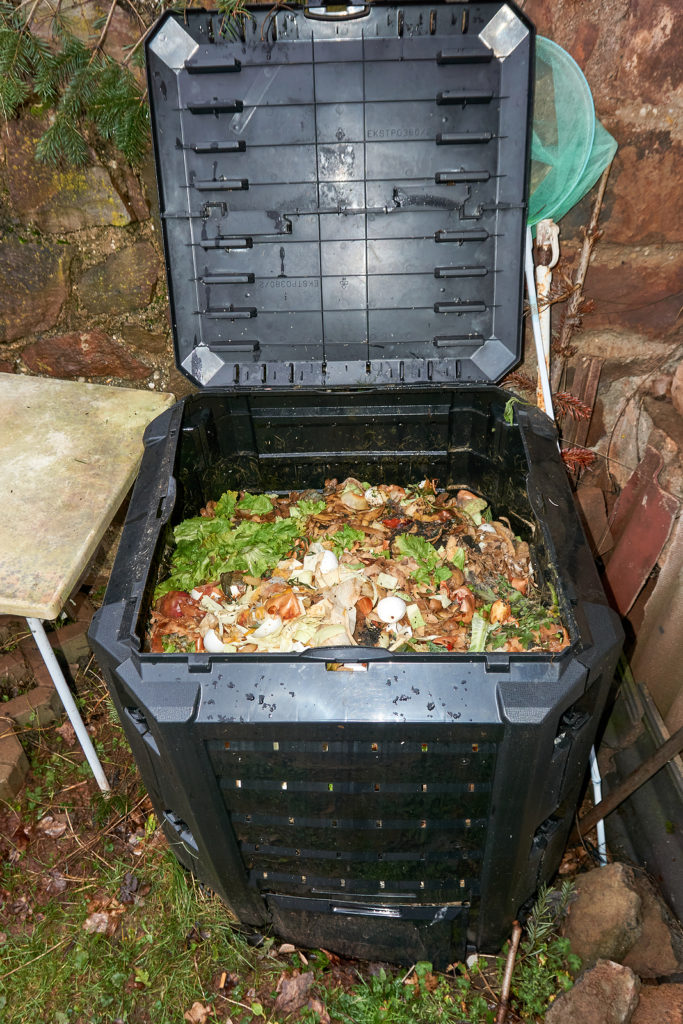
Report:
146,477,569,653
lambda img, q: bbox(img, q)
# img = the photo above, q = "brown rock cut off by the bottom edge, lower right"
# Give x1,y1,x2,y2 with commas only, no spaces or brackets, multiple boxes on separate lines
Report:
545,961,640,1024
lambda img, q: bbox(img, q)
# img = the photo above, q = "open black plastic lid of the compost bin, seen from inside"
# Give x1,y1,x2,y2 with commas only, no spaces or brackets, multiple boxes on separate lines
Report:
146,3,533,388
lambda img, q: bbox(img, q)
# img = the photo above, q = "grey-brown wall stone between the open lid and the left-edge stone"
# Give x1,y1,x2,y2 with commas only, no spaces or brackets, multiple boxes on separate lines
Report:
77,242,161,313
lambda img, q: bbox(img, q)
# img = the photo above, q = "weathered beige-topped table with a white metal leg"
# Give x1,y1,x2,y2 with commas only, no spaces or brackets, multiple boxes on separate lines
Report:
0,373,174,792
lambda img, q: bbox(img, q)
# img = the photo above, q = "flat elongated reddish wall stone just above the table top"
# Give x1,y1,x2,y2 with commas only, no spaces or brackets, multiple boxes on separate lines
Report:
22,330,152,380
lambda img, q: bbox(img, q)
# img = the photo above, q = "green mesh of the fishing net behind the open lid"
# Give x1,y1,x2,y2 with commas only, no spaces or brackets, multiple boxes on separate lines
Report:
527,36,616,225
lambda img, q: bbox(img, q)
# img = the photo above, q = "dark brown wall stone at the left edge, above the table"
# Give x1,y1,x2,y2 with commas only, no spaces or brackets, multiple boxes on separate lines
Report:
0,234,71,342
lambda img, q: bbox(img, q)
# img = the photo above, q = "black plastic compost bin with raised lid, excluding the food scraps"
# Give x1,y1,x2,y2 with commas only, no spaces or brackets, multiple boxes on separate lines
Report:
90,3,621,966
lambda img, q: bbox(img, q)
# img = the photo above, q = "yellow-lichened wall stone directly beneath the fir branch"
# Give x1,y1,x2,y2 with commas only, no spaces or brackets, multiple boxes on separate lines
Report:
6,117,131,233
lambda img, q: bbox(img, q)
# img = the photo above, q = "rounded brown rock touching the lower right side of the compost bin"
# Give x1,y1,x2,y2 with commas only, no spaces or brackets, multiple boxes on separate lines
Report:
564,864,643,968
